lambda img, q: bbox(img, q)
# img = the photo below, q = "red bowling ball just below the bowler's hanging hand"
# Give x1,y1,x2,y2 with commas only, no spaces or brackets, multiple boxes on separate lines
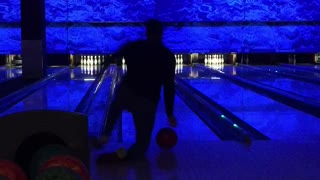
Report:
156,127,178,149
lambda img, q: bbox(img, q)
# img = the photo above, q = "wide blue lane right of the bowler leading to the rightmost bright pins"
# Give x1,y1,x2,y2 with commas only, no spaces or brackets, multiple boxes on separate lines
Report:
177,66,320,141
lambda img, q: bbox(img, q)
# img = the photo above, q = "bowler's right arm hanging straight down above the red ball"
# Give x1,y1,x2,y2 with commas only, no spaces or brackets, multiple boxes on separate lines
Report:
163,53,176,125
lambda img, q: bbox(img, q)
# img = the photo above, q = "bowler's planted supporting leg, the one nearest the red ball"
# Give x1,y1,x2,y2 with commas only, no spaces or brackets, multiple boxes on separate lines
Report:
127,101,157,159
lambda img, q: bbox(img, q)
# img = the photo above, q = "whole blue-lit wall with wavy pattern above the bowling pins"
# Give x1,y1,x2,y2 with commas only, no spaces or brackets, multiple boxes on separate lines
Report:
0,0,320,53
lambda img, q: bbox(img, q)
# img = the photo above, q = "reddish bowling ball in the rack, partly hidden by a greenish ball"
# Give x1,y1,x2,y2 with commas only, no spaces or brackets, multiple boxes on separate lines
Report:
40,155,90,180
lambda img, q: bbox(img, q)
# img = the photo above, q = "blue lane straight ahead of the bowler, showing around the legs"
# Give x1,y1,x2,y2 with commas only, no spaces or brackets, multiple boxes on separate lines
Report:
117,93,220,145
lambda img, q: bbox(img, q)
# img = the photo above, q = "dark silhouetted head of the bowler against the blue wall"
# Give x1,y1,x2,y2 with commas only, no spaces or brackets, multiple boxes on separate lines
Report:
145,19,163,41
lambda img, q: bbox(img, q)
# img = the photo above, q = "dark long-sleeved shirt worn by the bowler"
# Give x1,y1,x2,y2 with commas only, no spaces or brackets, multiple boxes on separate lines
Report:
115,40,176,116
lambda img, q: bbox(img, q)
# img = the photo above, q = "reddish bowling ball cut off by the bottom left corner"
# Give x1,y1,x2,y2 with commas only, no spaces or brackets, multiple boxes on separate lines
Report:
0,160,27,180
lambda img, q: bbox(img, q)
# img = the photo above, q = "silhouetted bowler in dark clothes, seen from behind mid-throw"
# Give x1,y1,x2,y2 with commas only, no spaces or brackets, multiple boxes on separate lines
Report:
98,20,176,162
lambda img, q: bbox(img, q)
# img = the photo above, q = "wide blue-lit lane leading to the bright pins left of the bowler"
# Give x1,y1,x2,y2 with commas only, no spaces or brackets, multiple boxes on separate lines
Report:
0,67,101,116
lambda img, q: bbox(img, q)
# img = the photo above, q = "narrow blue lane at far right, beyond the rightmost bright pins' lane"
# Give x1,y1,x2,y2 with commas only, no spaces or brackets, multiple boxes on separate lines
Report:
218,66,320,103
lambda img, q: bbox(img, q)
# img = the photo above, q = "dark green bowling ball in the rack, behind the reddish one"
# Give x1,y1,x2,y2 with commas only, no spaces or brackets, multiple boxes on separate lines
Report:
29,144,69,179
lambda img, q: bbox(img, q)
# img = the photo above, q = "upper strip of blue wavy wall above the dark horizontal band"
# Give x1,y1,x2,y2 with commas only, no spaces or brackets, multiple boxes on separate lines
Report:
0,0,320,22
